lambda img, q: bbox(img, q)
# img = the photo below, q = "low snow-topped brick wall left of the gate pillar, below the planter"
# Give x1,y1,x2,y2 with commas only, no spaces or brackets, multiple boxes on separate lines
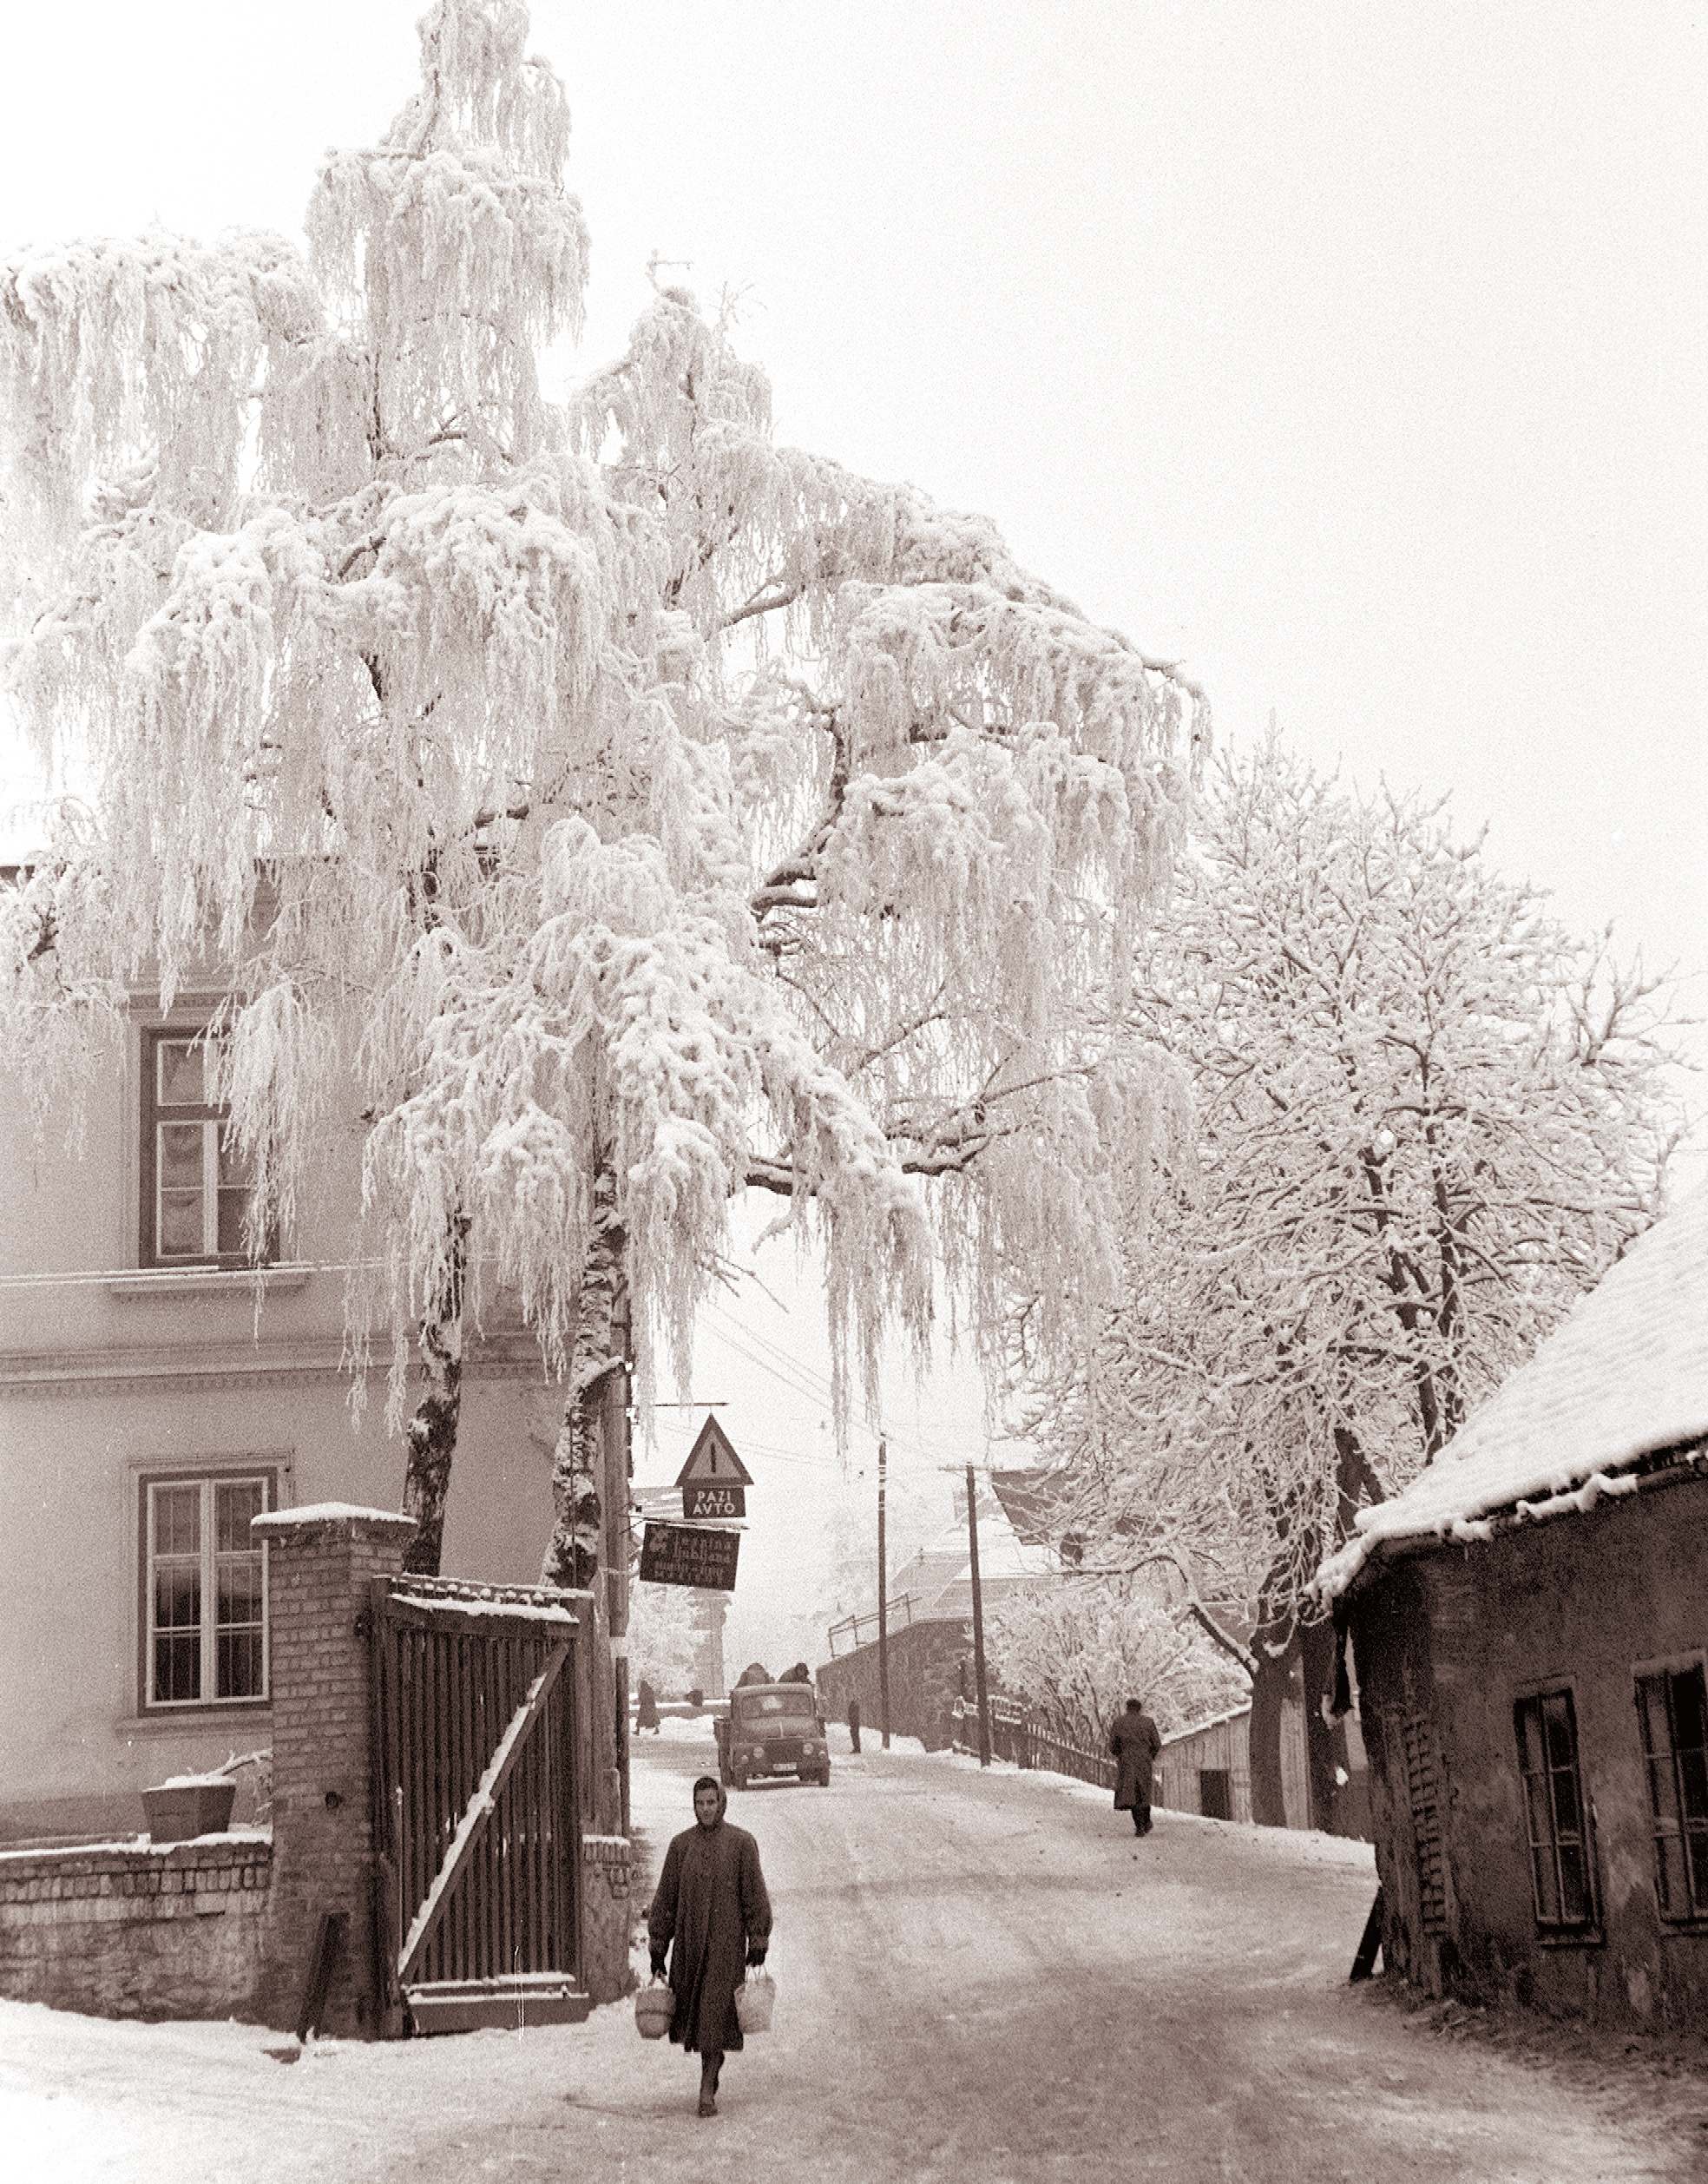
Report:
0,1834,273,2020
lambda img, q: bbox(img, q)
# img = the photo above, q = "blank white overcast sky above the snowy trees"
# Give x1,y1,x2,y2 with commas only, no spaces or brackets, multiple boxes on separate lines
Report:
0,0,1708,1615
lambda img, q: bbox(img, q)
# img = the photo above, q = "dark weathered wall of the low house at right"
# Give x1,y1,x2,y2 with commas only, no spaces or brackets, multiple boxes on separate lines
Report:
1352,1474,1708,2029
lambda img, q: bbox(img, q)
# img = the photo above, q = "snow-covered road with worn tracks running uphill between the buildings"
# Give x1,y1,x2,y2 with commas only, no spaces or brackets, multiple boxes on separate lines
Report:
0,1723,1708,2184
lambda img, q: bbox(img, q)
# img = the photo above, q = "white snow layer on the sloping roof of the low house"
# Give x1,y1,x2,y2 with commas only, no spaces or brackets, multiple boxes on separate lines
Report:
1315,1188,1708,1599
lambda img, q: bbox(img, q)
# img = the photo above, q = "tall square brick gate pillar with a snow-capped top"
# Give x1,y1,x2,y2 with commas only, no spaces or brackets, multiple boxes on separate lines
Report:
253,1503,415,2037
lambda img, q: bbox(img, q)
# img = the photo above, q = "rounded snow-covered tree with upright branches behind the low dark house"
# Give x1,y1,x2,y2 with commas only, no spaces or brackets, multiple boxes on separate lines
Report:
1017,738,1678,1821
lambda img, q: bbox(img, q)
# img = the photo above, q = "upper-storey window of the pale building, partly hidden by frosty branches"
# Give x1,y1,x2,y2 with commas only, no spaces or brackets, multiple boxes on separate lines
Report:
142,1031,278,1266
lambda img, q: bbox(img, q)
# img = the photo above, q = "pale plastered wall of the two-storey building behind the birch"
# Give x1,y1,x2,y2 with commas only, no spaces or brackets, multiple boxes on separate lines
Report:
0,1004,568,1844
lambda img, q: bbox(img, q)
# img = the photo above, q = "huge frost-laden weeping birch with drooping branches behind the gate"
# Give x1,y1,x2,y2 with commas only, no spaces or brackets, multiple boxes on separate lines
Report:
0,0,1208,1583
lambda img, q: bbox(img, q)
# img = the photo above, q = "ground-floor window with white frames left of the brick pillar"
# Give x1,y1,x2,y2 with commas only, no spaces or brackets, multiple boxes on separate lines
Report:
142,1472,275,1706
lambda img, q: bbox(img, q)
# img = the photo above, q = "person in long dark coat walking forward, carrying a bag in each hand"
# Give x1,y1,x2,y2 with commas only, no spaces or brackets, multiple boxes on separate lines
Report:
647,1776,771,2116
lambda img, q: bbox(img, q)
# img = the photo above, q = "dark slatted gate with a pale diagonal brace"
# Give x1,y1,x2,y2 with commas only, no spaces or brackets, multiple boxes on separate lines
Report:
369,1577,592,2031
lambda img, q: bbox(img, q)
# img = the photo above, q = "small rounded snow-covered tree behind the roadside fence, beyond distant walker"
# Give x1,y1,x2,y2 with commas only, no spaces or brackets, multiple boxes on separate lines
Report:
985,1577,1250,1752
